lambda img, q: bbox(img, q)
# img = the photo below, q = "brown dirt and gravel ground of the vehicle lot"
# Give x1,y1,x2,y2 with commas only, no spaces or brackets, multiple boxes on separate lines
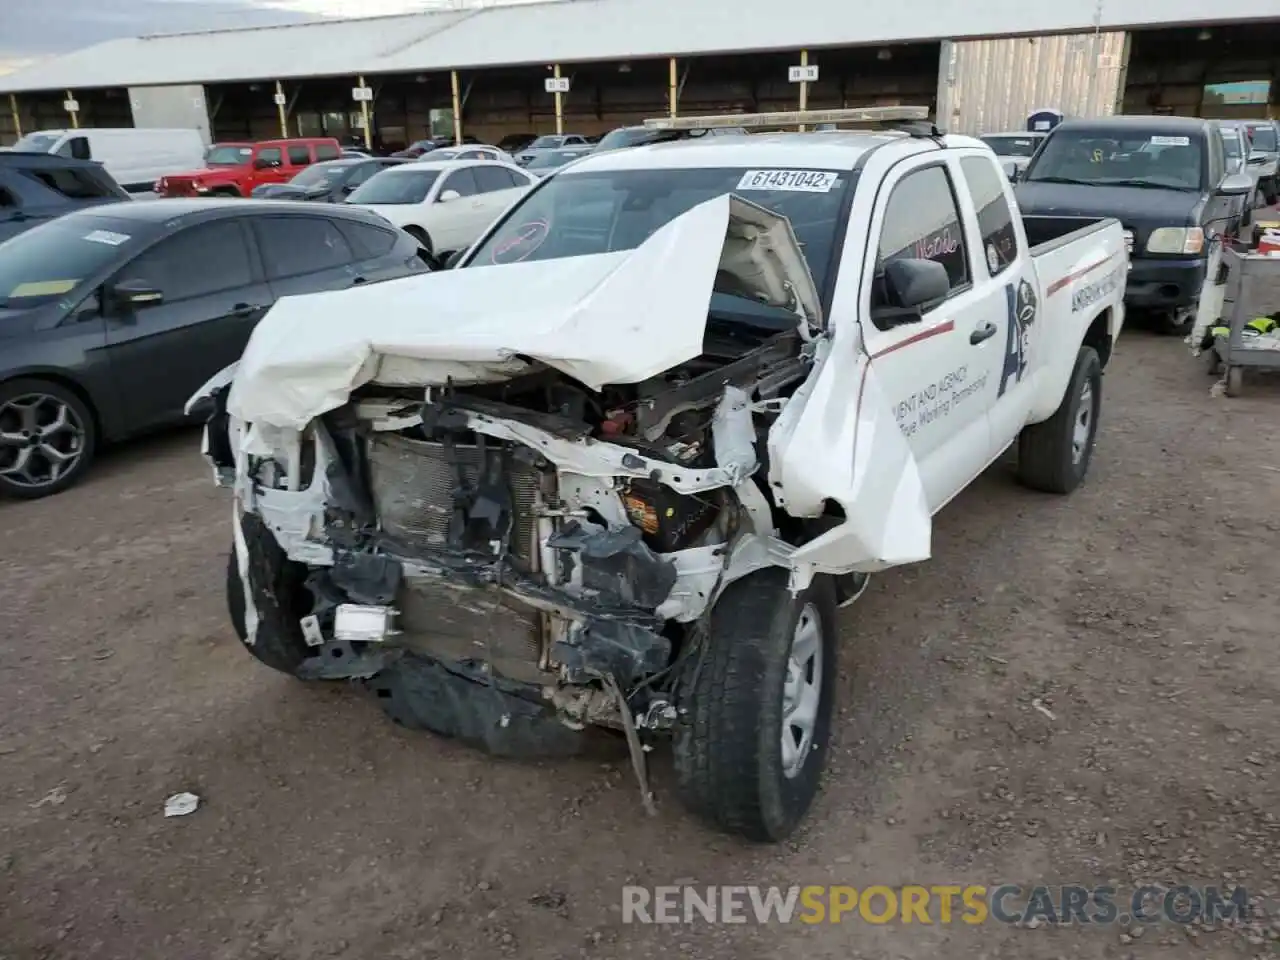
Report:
0,330,1280,960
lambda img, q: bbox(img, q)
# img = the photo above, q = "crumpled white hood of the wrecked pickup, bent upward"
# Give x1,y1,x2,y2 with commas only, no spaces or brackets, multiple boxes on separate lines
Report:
228,195,820,430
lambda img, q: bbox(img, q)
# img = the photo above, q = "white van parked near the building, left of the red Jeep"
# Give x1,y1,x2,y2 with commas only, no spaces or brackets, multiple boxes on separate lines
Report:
13,127,205,193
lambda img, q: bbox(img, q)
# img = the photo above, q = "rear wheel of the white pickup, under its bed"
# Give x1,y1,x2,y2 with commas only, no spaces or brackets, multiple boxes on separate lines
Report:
1018,347,1102,494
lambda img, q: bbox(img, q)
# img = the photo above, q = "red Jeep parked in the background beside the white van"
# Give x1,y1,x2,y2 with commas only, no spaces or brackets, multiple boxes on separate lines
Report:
155,137,342,197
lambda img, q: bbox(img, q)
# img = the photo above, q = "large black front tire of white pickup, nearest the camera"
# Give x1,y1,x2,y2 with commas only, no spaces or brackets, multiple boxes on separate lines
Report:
675,568,836,842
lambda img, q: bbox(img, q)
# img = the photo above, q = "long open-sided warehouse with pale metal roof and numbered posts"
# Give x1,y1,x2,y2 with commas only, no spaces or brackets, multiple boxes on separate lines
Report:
0,0,1280,147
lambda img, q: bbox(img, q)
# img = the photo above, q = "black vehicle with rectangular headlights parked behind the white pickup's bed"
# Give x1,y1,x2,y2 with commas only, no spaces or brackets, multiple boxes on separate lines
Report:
1016,116,1253,333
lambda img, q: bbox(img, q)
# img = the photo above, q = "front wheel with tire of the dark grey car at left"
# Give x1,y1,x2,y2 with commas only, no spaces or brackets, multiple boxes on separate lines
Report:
0,378,97,500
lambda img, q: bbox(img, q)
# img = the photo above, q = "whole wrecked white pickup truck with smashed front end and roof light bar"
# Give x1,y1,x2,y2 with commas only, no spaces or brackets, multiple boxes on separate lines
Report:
192,109,1126,841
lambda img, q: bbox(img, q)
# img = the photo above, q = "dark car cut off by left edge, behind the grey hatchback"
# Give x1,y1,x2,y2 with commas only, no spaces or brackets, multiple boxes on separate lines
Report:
0,150,131,243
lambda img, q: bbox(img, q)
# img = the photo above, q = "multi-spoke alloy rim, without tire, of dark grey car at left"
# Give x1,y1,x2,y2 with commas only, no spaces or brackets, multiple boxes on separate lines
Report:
0,393,84,490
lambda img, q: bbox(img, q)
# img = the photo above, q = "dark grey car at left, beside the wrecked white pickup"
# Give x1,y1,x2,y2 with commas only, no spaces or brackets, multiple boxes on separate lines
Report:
0,198,429,499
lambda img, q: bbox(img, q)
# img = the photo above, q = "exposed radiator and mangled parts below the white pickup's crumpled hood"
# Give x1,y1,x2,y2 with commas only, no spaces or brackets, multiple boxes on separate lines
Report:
224,309,812,726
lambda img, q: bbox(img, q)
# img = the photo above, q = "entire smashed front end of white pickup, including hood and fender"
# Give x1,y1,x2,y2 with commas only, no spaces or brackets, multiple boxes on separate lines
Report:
197,195,928,819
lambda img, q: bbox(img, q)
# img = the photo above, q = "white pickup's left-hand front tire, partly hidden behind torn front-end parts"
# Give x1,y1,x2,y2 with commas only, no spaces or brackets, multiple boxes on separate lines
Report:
227,515,312,675
